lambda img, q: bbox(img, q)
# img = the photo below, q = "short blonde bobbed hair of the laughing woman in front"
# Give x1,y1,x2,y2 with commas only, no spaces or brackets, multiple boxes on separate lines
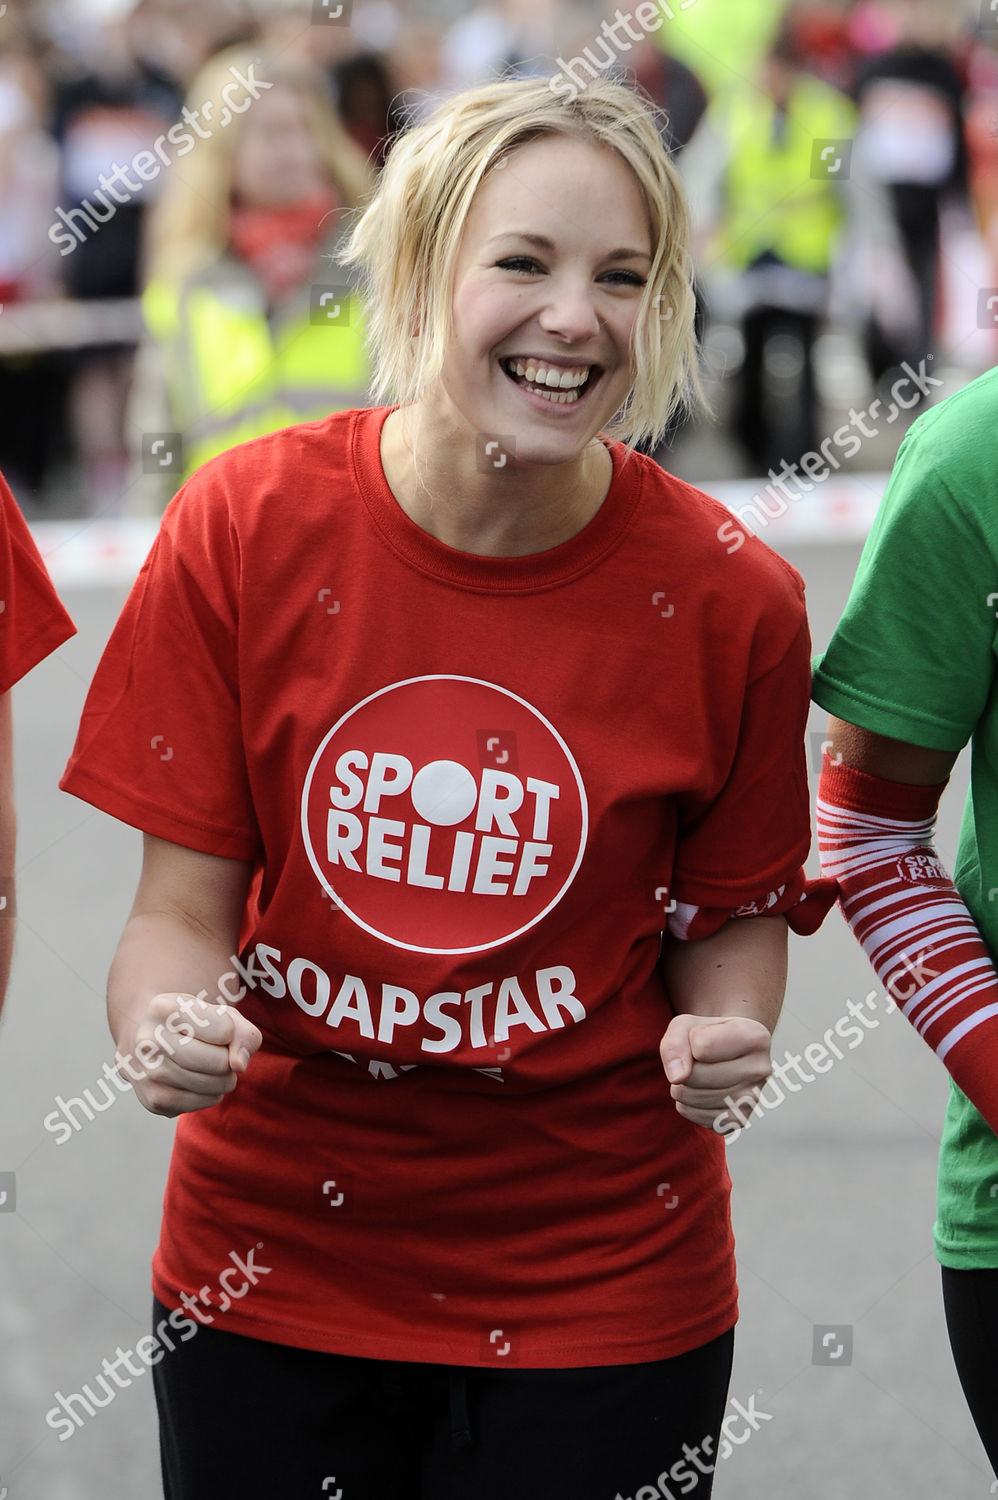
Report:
339,78,702,444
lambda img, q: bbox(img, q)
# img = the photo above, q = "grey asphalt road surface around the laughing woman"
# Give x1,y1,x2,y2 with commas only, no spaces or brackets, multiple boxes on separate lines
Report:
0,546,992,1500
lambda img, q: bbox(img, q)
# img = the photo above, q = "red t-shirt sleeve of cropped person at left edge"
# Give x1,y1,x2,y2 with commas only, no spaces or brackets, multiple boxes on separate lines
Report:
0,479,77,693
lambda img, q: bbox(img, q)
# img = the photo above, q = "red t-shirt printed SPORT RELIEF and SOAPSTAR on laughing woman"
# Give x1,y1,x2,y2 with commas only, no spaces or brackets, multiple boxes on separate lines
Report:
63,410,809,1367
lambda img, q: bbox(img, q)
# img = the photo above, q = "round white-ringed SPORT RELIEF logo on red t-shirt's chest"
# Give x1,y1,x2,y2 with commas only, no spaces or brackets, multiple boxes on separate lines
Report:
302,675,588,953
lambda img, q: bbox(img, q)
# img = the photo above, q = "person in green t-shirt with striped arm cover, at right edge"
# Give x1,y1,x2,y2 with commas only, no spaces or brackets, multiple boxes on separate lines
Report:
813,371,998,1472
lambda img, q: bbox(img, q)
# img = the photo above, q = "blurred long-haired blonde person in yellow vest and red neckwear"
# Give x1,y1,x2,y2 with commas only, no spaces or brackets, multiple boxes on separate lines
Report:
132,50,371,503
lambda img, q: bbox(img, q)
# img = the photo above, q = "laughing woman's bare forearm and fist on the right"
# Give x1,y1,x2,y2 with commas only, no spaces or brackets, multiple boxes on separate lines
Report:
659,917,786,1130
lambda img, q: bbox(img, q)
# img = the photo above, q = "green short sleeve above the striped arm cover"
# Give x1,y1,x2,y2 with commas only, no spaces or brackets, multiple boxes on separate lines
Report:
813,431,998,750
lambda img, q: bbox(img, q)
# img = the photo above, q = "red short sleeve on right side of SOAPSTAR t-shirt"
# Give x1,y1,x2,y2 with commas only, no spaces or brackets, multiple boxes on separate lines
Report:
672,608,810,911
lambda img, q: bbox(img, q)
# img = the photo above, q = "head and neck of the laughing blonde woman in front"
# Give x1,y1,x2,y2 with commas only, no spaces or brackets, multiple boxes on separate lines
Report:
344,80,699,557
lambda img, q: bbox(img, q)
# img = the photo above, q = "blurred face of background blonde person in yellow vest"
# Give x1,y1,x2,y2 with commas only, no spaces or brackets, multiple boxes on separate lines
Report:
233,84,324,209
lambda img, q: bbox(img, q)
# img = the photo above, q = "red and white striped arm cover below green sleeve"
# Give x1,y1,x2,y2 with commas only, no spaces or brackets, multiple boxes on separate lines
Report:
816,755,998,1131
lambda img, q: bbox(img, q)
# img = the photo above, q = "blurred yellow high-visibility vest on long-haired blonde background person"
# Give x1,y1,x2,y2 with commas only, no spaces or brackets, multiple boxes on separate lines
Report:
143,261,371,480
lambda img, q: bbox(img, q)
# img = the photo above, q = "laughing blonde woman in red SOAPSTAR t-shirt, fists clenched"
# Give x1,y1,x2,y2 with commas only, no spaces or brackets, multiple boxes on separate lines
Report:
65,81,821,1500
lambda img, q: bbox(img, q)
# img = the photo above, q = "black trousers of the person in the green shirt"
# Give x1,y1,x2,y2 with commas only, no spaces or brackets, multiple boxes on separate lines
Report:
942,1266,998,1475
